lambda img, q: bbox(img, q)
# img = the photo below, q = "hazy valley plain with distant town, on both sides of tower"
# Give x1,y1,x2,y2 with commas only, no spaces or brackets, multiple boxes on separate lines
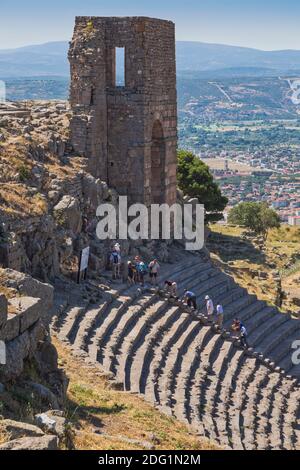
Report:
0,72,300,225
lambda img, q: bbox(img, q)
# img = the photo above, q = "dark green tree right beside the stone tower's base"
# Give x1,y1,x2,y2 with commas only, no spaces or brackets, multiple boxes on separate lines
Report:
177,150,228,222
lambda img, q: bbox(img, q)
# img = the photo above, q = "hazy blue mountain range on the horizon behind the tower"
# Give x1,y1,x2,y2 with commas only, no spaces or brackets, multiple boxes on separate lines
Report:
0,41,300,78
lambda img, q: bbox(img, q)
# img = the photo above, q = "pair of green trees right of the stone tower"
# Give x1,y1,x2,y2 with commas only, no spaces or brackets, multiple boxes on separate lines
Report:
177,150,280,236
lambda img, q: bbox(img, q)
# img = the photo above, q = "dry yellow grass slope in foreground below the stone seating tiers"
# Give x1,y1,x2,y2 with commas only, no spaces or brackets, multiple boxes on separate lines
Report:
53,338,217,450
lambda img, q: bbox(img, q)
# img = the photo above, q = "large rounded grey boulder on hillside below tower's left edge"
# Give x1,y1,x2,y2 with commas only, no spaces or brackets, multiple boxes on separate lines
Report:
53,196,82,234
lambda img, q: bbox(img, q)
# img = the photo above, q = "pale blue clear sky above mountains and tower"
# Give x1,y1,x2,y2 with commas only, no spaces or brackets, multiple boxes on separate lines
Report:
0,0,300,50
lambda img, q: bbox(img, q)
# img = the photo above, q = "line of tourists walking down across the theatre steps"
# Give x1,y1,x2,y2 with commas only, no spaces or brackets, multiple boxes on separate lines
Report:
109,243,249,348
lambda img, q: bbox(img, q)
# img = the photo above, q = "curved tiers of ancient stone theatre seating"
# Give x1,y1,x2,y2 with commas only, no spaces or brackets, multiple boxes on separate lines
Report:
53,253,300,449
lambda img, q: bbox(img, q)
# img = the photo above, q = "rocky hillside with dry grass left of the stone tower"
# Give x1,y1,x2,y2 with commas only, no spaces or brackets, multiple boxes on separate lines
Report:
0,102,113,281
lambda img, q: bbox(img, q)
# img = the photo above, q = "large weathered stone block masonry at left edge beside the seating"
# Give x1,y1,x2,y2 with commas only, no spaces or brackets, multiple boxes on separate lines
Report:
0,269,66,392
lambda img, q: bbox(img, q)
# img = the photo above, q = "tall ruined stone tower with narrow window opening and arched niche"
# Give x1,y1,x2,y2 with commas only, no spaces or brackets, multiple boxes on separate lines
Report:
69,17,177,204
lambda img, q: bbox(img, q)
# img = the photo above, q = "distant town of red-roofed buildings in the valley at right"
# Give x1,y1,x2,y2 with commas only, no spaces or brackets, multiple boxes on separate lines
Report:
199,149,300,225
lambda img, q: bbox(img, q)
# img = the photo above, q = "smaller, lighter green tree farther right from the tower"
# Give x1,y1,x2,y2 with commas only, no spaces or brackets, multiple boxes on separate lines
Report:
228,202,280,237
